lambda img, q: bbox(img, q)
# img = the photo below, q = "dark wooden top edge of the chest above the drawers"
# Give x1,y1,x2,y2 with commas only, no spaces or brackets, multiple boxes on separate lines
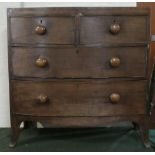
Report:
8,7,149,17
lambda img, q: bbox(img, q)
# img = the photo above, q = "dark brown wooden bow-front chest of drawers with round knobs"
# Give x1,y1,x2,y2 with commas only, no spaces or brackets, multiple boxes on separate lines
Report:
8,8,153,146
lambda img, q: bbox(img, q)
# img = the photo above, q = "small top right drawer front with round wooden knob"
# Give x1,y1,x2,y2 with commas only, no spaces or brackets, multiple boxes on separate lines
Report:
80,16,149,44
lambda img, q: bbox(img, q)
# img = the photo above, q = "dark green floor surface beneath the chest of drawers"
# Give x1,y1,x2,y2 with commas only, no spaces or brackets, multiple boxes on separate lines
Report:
0,127,155,152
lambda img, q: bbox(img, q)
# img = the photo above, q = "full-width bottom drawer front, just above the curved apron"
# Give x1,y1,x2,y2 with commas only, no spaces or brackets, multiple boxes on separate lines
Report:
11,80,146,116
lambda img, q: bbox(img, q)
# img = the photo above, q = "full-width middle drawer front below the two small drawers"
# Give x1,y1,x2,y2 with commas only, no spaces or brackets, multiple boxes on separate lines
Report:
11,47,146,78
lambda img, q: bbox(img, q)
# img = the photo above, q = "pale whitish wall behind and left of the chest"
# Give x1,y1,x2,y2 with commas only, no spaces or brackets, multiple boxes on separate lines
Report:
0,2,136,127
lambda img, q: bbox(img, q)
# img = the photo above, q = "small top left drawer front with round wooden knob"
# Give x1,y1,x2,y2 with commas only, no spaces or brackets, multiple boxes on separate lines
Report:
10,17,75,44
